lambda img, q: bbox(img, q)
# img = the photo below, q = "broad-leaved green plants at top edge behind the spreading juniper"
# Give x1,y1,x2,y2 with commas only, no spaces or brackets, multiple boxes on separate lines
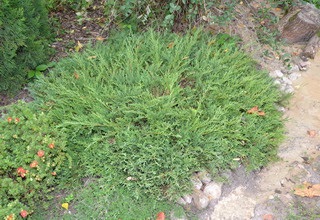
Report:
105,0,210,30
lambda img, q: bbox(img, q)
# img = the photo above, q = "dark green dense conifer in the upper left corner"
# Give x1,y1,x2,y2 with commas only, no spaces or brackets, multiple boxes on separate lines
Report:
0,0,50,92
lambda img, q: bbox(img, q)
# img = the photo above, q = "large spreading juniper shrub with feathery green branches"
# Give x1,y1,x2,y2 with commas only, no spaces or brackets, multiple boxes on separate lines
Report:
32,31,282,204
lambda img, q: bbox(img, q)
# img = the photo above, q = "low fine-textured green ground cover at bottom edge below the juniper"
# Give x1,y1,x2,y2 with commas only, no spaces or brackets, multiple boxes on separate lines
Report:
32,178,181,220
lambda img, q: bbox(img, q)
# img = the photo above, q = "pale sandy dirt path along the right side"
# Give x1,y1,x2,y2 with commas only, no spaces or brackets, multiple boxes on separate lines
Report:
208,55,320,220
